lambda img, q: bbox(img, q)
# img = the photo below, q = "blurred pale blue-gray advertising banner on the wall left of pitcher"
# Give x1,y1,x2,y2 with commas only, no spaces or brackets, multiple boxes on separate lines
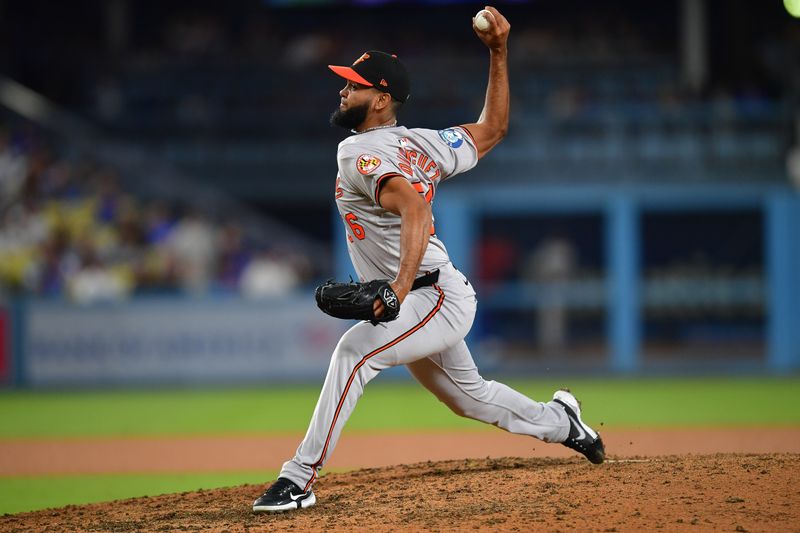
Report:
22,294,349,386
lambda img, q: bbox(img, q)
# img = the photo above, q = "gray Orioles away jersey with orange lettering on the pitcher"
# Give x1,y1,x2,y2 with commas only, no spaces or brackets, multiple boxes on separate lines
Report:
336,126,478,281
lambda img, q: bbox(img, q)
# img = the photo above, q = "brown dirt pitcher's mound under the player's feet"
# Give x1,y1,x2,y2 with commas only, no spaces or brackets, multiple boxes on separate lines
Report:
0,454,800,532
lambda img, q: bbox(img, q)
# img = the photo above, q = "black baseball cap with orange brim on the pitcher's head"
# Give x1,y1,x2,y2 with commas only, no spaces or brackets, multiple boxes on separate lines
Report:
328,50,411,102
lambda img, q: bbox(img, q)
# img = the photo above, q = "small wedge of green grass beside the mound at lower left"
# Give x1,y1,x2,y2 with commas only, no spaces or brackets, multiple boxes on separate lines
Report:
0,472,277,514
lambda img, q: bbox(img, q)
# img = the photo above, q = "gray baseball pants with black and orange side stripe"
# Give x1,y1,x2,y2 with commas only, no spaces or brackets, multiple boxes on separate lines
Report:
280,264,569,490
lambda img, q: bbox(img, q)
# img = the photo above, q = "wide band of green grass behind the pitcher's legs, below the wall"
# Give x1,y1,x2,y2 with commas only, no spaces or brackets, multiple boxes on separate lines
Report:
0,378,800,439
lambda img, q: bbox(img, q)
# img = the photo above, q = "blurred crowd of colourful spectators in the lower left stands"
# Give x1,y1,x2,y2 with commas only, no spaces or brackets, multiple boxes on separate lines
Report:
0,123,313,303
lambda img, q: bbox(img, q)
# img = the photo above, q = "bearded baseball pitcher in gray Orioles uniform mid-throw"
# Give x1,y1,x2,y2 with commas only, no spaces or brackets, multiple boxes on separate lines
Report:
253,7,605,512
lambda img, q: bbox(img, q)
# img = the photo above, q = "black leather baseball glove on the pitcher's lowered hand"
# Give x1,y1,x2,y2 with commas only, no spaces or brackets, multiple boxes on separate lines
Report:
314,279,400,324
